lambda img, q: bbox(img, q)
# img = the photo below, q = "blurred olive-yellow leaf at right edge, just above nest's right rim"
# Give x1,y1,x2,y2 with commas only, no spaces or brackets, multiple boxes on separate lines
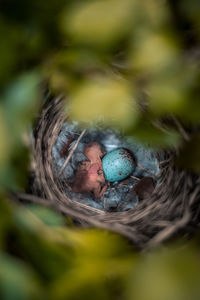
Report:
148,58,198,119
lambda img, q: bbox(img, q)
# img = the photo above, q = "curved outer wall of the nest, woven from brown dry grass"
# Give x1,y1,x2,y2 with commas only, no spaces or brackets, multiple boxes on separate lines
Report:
29,98,200,248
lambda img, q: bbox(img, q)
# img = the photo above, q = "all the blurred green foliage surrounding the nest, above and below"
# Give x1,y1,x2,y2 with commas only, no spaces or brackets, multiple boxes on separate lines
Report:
0,0,200,300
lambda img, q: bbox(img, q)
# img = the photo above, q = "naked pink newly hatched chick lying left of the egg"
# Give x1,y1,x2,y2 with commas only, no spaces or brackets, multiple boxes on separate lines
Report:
72,142,107,198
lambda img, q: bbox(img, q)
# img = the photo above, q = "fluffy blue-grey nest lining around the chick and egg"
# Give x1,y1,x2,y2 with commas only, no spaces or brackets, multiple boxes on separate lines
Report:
52,122,159,212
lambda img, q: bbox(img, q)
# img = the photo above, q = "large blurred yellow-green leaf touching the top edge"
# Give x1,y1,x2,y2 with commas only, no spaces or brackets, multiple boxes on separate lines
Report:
61,0,135,47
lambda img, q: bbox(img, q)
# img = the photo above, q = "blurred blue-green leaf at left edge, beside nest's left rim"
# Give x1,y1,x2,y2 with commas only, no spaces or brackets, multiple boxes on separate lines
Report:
0,71,40,190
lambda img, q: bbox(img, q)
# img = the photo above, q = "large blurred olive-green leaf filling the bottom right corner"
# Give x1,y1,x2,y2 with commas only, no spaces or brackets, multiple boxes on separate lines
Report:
128,246,200,300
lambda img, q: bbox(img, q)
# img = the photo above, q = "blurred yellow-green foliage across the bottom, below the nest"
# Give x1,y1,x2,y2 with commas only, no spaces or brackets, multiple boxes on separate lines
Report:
0,195,200,300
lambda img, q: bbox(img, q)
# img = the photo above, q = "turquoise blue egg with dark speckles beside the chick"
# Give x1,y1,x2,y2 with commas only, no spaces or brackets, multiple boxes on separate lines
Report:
102,148,135,182
